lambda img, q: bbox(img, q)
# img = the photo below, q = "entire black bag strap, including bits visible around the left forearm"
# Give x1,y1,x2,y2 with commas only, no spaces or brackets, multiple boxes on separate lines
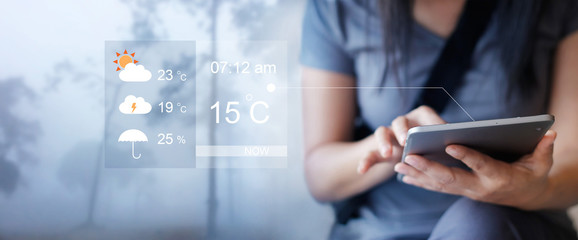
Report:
332,0,498,224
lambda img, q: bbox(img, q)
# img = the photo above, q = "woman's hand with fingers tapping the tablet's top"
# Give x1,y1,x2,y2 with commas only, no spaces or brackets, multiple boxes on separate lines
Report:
357,106,445,174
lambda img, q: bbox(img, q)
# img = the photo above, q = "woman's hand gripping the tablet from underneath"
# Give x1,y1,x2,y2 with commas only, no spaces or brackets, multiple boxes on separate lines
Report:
395,130,556,210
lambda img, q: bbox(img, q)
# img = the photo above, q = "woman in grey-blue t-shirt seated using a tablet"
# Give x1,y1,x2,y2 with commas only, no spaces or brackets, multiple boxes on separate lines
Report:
301,0,578,239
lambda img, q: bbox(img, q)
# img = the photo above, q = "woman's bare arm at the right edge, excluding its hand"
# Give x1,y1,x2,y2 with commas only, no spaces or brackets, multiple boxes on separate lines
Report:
540,33,578,208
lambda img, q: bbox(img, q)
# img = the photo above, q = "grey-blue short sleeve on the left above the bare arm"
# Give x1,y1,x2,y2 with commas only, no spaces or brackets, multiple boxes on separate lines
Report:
300,0,355,76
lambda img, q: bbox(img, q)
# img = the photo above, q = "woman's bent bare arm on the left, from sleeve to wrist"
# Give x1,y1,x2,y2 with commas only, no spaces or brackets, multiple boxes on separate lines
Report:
302,68,401,202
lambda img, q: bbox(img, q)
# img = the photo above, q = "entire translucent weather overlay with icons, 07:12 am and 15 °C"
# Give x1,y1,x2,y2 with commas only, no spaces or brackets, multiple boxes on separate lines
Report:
104,41,288,168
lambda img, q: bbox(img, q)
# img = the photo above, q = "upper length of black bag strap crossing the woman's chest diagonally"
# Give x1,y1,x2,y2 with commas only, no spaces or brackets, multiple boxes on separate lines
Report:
412,0,498,113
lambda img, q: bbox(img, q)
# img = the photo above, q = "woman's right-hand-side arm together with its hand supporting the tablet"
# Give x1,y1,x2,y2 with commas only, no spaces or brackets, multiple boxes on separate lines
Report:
395,33,578,210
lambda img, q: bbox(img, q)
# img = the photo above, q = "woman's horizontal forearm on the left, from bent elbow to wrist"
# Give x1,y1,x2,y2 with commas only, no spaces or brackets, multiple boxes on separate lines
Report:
305,135,394,202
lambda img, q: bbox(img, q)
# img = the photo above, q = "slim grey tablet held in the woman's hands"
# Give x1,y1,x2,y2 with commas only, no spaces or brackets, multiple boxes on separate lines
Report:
398,114,554,180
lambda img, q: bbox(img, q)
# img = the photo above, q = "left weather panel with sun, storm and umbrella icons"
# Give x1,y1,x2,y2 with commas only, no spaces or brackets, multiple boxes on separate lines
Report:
104,41,196,168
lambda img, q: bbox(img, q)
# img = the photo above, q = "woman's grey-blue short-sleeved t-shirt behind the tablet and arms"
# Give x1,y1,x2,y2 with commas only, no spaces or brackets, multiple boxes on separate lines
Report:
300,0,578,239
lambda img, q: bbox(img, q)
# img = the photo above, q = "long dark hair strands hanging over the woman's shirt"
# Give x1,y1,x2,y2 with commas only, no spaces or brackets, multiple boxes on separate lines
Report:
379,0,545,97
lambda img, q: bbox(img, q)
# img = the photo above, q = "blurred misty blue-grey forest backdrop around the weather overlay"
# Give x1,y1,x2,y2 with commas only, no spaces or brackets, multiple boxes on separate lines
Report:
0,0,333,239
